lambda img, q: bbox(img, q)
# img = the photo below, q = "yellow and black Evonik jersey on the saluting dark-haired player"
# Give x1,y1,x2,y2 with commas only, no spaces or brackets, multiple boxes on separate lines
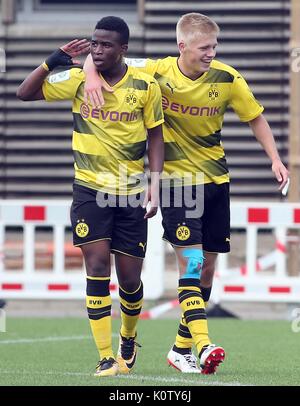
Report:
42,66,164,195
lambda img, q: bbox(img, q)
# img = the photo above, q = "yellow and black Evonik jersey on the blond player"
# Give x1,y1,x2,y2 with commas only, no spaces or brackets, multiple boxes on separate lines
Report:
126,57,264,184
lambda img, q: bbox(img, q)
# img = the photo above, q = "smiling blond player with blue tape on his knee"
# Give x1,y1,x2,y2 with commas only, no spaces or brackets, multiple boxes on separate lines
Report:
85,13,288,374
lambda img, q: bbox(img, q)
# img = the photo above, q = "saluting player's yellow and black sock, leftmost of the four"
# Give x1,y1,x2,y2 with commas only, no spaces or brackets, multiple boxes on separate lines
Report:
86,277,114,359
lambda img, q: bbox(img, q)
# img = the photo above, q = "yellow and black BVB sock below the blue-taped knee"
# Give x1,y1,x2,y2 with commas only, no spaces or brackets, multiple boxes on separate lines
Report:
176,278,211,354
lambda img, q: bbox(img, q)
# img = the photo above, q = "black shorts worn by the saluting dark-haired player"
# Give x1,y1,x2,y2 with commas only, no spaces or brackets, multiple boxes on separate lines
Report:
71,183,147,258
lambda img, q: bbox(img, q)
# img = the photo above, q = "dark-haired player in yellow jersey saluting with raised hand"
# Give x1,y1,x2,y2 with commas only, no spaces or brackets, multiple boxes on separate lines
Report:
17,17,164,377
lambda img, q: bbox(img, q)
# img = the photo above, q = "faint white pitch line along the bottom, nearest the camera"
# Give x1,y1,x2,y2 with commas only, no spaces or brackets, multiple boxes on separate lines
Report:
0,369,253,386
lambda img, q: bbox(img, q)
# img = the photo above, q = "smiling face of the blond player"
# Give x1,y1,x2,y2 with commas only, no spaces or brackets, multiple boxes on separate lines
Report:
179,33,218,73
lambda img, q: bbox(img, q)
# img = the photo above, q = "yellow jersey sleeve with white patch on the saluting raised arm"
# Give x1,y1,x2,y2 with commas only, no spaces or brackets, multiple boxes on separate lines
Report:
42,68,84,102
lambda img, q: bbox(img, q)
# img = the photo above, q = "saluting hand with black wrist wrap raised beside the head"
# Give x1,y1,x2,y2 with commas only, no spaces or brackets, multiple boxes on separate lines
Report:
45,39,90,71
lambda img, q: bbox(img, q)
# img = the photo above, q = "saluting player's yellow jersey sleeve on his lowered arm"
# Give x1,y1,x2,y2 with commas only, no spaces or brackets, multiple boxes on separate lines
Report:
143,79,164,128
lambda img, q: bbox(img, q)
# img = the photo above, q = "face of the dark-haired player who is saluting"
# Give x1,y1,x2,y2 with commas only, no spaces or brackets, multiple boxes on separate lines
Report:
91,29,127,72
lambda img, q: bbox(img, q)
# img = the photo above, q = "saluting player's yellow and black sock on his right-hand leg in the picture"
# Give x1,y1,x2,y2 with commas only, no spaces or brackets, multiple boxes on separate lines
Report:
119,282,143,338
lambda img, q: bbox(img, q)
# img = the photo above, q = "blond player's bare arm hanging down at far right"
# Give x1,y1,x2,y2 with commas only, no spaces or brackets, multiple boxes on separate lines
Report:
249,114,289,190
